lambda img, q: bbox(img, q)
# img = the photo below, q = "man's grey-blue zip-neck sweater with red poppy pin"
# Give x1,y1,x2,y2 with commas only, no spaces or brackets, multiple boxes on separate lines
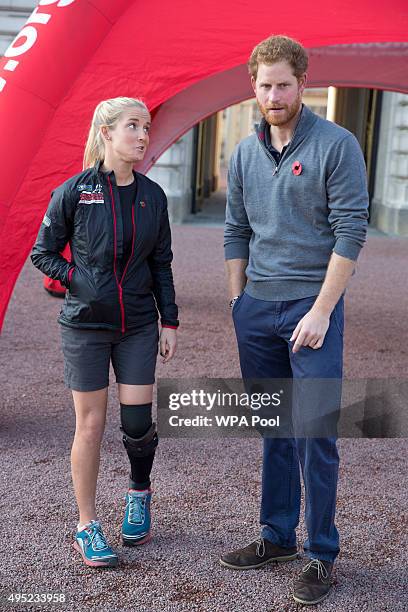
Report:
224,106,368,300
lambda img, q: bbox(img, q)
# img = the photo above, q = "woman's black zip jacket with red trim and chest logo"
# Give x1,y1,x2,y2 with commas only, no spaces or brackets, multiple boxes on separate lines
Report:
31,162,178,331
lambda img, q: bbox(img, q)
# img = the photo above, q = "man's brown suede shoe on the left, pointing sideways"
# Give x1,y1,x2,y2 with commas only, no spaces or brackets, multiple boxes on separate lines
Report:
220,537,297,570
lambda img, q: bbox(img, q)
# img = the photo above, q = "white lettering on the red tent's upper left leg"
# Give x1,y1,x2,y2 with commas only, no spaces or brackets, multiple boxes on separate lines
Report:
0,0,75,92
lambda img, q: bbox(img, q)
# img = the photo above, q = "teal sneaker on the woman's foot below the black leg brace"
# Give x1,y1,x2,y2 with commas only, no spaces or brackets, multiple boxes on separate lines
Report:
122,489,152,546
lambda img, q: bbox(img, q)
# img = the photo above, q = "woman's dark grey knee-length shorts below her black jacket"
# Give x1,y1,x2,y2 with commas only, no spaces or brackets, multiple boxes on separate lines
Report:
61,321,159,391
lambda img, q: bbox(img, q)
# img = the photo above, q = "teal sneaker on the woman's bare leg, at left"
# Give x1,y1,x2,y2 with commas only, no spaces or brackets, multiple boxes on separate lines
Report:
73,521,118,567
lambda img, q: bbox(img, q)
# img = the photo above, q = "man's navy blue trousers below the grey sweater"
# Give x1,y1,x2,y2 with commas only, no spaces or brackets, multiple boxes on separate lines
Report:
232,292,344,562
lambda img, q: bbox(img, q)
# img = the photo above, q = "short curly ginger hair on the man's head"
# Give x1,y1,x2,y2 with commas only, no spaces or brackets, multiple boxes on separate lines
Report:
248,36,309,79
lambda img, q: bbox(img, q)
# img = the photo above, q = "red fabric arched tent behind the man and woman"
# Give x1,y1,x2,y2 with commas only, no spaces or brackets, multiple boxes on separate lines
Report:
0,0,408,325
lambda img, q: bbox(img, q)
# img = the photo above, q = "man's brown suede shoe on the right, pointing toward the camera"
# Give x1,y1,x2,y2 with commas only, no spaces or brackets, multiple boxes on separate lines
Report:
293,559,333,606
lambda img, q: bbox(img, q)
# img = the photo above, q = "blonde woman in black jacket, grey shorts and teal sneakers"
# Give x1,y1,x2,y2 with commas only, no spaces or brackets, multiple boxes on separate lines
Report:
31,98,178,567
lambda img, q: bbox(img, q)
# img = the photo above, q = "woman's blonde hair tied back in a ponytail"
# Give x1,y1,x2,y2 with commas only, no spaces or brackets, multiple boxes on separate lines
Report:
83,97,149,170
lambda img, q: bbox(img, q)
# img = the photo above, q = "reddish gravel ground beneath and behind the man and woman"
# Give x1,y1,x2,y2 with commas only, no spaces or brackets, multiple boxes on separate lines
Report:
0,226,408,612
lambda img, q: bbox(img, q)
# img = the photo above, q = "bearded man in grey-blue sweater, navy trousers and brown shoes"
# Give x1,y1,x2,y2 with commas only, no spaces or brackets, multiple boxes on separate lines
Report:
220,36,368,605
